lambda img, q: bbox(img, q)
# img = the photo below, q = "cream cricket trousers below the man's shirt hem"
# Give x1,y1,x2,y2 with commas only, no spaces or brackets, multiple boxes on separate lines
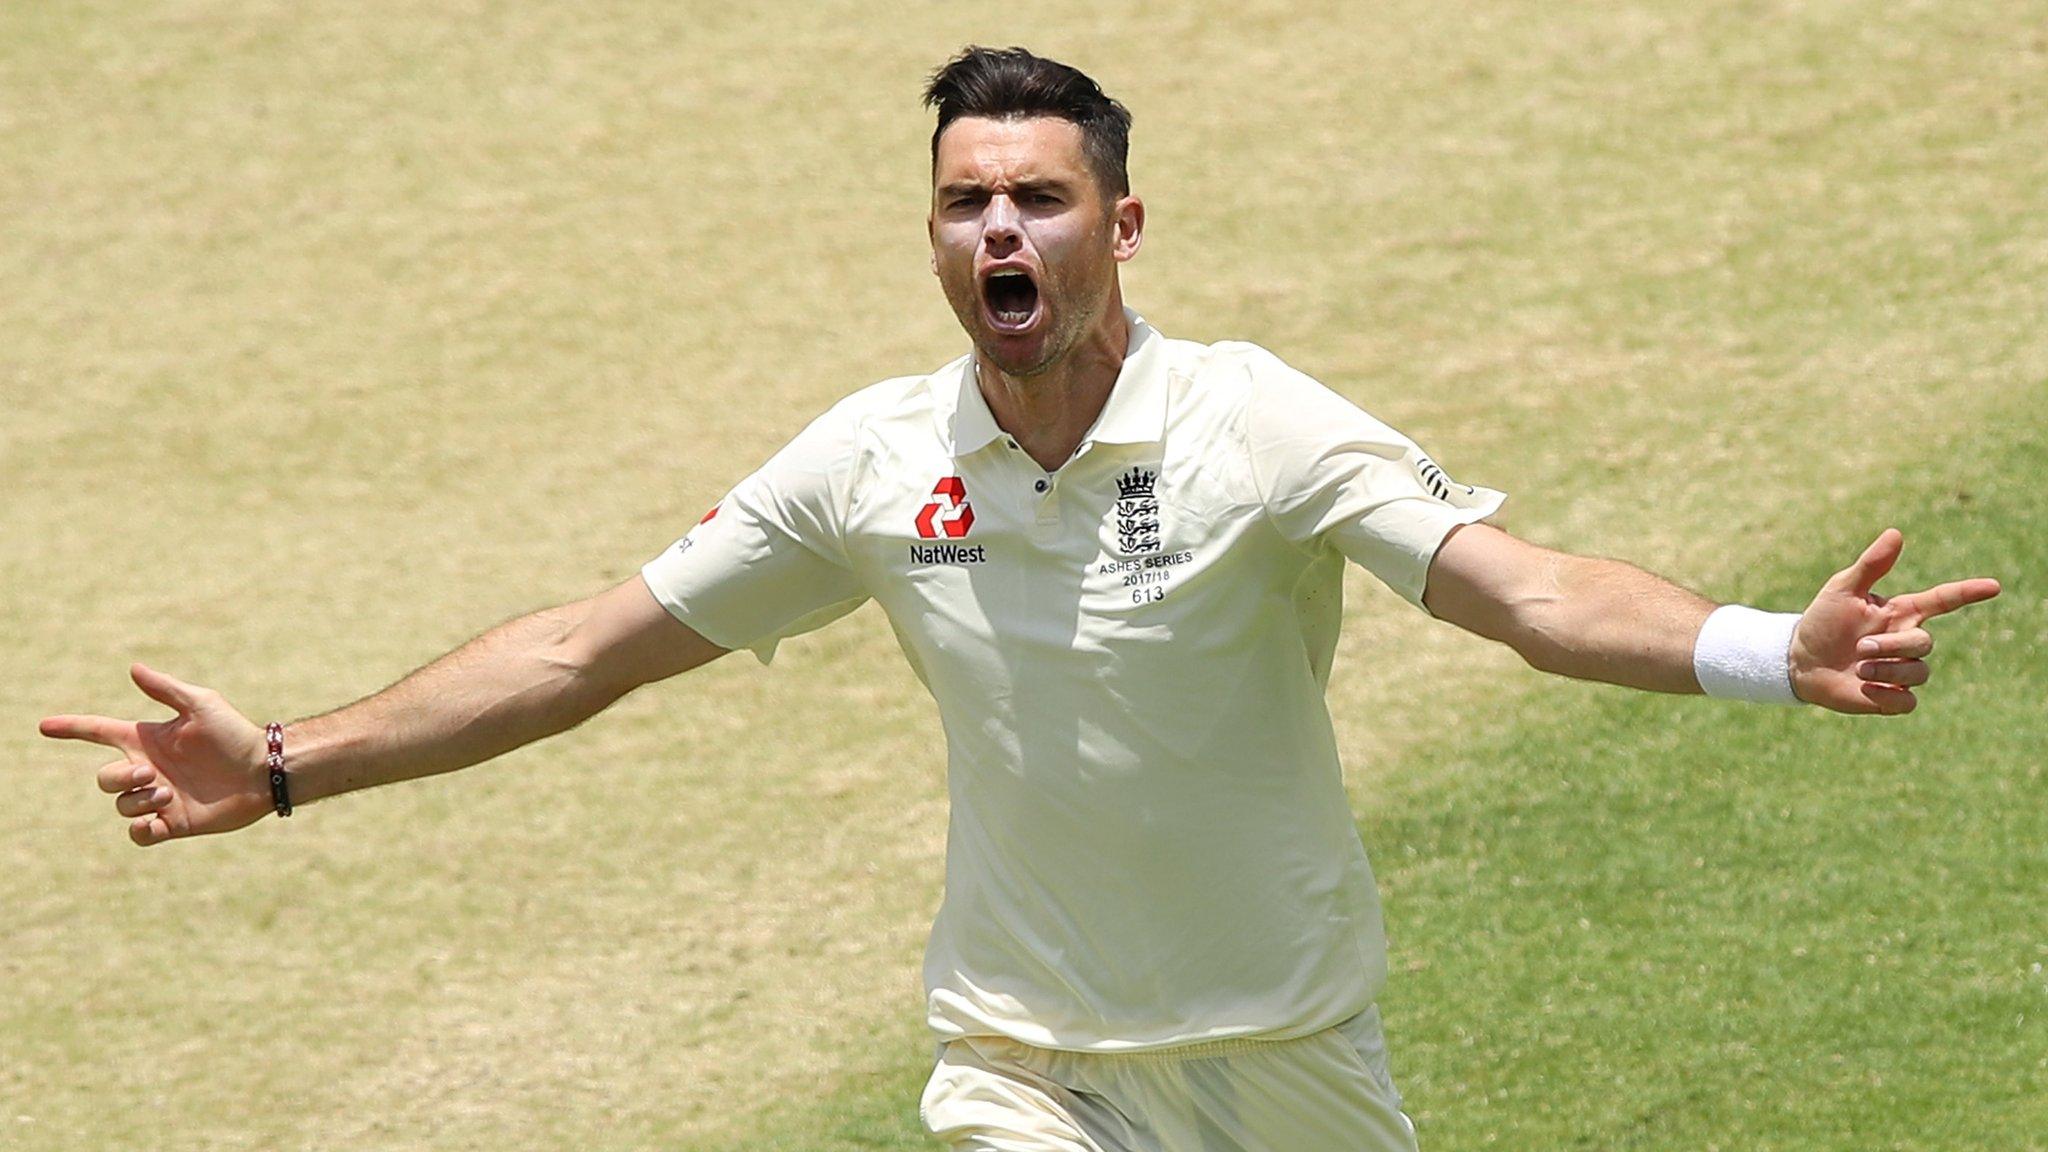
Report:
920,1006,1415,1152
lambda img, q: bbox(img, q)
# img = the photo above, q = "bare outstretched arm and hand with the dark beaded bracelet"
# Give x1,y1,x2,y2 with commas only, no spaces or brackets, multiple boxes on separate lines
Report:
41,576,725,845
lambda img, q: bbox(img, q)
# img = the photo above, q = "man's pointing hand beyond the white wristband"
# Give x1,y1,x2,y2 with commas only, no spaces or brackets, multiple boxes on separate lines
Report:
1792,529,1999,715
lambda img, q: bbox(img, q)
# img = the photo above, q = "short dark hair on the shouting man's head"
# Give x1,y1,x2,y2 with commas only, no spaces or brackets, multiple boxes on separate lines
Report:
924,45,1130,197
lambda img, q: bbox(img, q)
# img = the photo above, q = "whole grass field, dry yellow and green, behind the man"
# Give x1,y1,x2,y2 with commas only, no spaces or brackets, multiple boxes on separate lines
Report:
0,0,2048,1152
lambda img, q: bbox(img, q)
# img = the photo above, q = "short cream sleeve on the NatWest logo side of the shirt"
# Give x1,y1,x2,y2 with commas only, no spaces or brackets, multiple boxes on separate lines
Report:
641,406,868,664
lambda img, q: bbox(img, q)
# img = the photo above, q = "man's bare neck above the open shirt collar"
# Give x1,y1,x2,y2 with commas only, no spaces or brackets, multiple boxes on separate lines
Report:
975,293,1130,471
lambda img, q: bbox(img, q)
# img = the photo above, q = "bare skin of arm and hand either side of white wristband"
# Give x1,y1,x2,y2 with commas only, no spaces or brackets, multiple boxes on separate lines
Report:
1423,525,1999,713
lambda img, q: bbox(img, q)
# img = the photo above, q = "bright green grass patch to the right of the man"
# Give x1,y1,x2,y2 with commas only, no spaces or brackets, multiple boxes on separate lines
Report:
1366,401,2048,1150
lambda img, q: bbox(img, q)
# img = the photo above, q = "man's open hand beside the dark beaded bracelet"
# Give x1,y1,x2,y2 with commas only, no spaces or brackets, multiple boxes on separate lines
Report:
37,664,272,847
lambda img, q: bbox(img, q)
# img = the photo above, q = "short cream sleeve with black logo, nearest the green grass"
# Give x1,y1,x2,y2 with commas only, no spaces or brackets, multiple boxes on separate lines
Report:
1245,351,1505,607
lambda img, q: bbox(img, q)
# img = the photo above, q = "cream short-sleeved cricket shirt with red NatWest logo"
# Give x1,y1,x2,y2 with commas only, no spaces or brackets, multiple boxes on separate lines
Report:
643,314,1501,1052
